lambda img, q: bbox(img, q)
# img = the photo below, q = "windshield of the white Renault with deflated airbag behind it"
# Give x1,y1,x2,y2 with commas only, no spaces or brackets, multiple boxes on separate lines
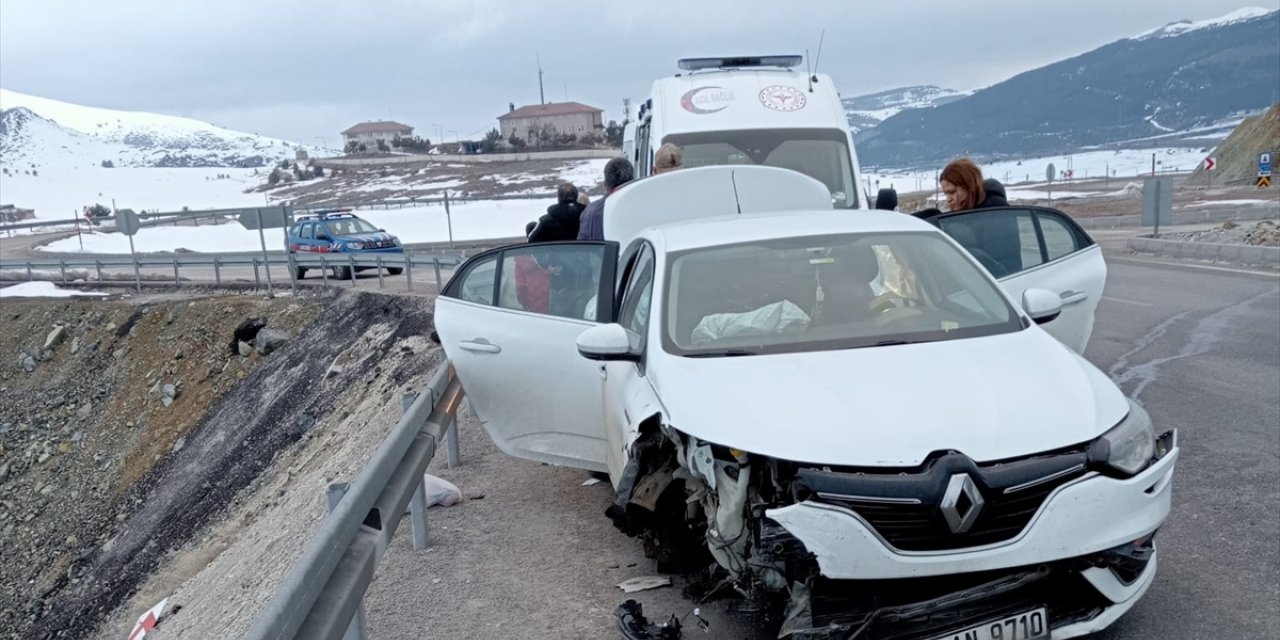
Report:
663,232,1024,357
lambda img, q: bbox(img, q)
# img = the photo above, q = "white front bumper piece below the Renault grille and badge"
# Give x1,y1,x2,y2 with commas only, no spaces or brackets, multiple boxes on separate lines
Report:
765,449,1179,580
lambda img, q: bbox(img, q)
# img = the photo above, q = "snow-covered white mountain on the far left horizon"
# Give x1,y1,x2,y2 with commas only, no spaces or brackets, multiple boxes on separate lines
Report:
0,88,317,169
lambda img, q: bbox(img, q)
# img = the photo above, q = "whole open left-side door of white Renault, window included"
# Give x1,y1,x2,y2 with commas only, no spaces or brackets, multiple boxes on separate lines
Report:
435,242,618,471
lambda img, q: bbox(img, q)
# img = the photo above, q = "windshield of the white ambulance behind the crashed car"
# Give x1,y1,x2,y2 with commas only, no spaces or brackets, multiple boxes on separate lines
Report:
663,129,858,209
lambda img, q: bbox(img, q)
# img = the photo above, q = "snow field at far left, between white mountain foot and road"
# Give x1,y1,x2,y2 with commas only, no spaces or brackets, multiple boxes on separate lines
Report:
0,166,266,220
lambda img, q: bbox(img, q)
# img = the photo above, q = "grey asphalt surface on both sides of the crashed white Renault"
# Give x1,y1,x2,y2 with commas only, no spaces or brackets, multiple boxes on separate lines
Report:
366,256,1280,640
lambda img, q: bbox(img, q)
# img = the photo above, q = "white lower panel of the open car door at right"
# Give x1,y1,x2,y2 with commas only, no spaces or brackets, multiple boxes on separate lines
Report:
1000,244,1107,353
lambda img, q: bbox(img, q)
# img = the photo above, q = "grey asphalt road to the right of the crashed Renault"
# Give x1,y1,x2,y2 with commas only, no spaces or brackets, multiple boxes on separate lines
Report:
1085,256,1280,640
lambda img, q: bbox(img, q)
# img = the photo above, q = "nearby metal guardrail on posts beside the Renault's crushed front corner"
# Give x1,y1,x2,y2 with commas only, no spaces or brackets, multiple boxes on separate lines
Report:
244,360,463,640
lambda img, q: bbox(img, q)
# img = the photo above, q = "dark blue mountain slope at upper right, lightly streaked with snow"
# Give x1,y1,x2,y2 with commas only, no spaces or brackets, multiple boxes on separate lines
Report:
858,9,1280,168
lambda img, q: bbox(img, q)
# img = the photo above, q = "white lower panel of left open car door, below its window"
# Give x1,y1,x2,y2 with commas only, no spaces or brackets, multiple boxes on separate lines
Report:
435,296,608,471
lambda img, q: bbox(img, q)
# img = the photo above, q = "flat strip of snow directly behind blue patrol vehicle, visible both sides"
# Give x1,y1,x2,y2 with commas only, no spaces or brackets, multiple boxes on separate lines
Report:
41,198,550,253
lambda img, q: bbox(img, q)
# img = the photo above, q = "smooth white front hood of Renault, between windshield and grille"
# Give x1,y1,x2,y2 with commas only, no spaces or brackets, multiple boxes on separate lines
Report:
649,328,1128,466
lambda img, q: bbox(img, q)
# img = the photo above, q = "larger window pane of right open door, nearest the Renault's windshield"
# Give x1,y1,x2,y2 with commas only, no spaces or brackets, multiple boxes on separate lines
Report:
940,210,1044,278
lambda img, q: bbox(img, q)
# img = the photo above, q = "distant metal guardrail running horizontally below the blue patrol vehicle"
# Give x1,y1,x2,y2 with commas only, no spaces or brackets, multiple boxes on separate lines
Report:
0,252,463,292
